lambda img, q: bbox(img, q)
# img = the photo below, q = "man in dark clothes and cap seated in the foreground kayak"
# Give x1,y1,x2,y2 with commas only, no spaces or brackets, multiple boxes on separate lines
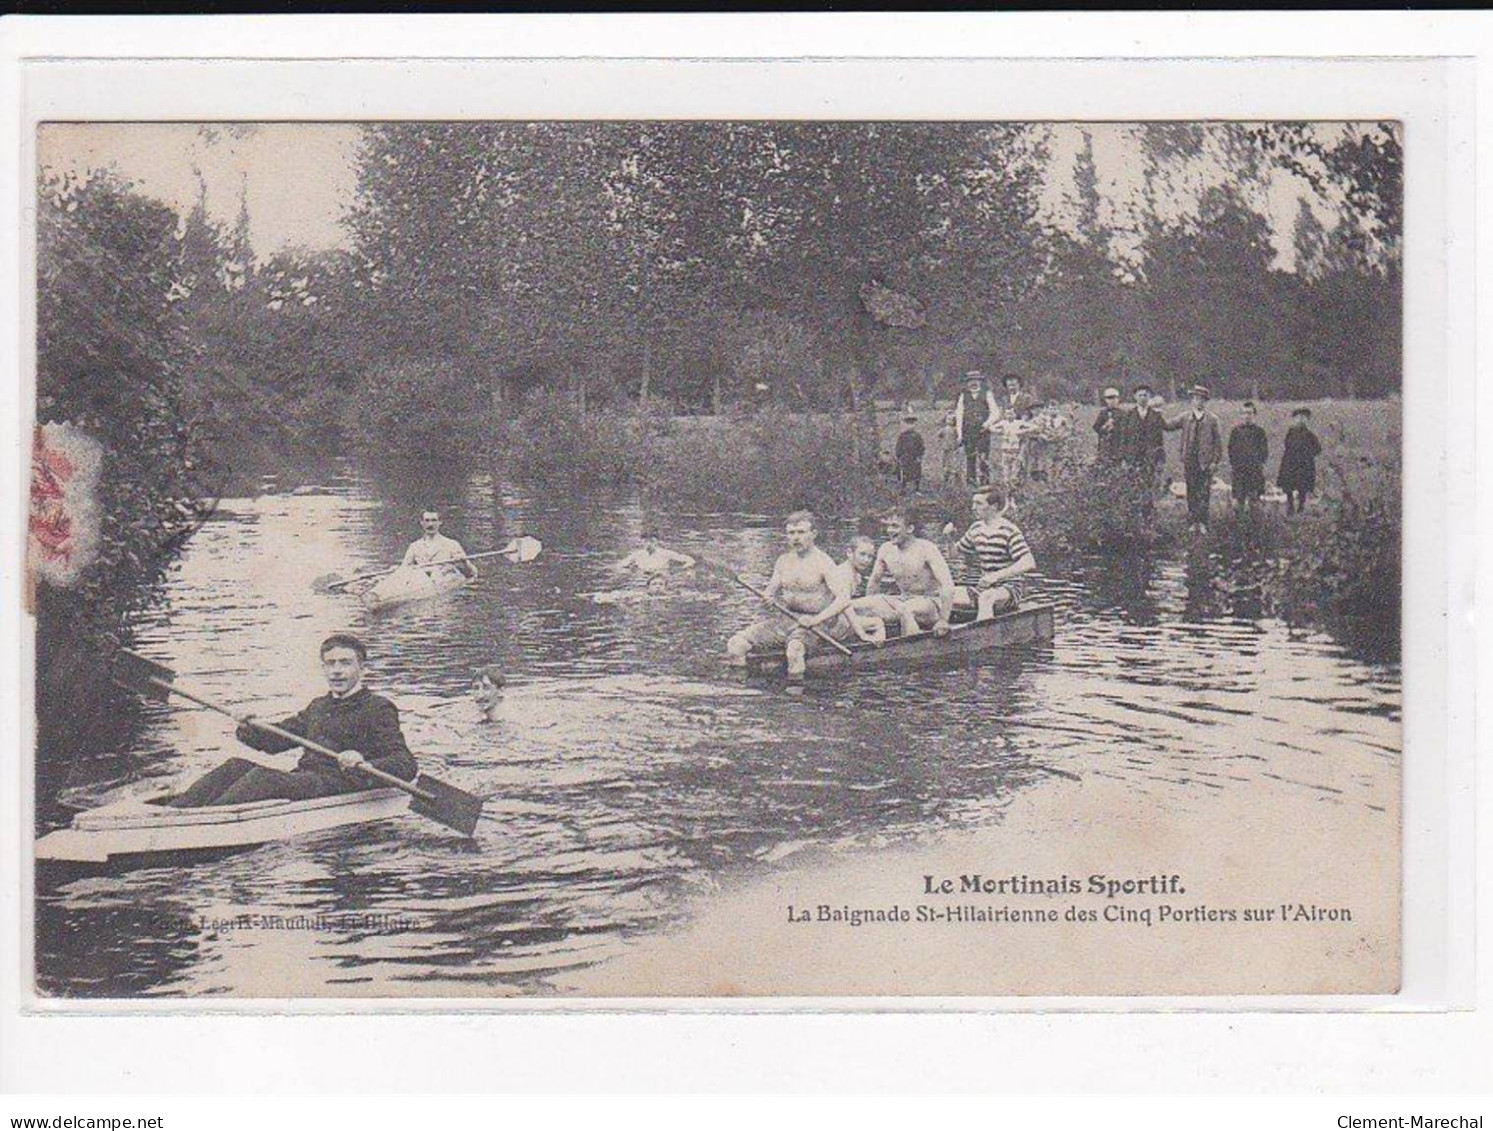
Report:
172,633,418,809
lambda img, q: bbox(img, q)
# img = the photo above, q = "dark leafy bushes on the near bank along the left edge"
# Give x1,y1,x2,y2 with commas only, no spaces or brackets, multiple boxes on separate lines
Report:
36,176,216,805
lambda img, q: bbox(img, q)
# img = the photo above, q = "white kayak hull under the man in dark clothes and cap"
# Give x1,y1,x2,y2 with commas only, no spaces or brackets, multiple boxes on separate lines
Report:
36,788,409,864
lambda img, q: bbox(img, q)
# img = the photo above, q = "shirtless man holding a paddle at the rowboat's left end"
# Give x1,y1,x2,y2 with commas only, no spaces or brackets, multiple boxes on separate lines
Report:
726,510,854,679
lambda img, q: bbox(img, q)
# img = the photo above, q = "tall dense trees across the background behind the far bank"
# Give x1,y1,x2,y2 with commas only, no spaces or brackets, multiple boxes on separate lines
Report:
157,122,1402,470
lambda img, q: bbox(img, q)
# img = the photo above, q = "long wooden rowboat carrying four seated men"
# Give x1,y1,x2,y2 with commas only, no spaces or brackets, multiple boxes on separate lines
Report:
747,604,1054,676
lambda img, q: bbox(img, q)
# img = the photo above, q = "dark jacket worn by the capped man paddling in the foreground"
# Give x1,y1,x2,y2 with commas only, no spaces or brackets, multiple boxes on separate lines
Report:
237,688,420,789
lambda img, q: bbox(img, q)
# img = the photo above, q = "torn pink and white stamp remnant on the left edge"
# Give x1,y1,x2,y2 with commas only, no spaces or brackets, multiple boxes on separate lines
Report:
27,424,100,588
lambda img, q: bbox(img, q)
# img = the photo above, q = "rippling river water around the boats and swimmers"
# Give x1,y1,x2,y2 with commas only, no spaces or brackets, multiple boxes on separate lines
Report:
37,474,1400,997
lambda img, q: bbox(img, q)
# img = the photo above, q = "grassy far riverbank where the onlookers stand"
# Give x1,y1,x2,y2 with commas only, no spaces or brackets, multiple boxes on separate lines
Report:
493,400,1402,657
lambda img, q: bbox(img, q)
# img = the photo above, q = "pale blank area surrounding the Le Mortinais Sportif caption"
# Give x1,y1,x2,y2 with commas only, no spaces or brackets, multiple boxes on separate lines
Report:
564,767,1400,997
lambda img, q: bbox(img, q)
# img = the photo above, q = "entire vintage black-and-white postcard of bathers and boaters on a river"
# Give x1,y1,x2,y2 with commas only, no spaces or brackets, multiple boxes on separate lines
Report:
27,105,1406,1004
